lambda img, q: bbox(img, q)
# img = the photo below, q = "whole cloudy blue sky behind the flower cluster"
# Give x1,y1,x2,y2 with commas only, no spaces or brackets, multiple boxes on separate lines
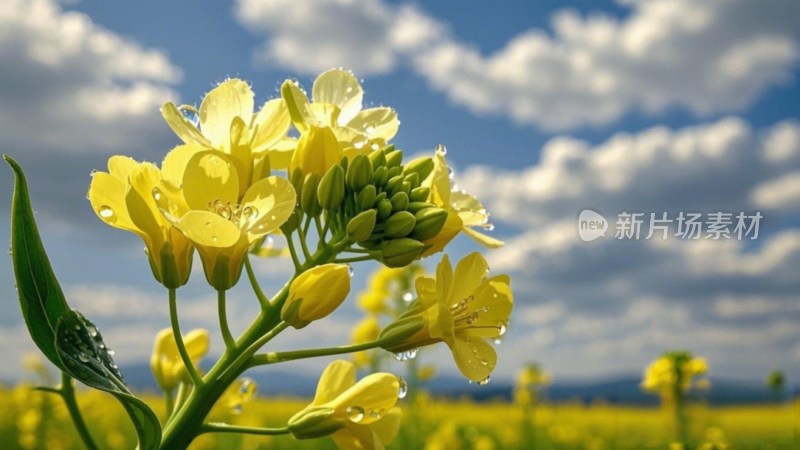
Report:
0,0,800,381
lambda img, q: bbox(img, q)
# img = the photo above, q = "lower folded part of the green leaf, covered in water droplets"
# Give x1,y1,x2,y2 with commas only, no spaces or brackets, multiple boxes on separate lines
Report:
56,310,161,450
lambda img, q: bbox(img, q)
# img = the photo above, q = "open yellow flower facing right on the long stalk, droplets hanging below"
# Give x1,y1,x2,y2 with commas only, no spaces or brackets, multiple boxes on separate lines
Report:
381,252,514,382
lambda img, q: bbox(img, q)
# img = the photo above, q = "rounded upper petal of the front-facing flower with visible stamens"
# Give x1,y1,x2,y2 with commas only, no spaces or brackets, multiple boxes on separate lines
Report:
183,151,239,210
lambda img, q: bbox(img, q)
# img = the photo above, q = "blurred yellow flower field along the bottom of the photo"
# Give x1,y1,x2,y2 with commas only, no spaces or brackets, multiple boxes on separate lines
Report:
0,385,800,450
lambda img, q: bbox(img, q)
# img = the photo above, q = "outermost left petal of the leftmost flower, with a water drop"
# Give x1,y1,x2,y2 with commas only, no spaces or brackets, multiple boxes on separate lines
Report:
89,172,142,235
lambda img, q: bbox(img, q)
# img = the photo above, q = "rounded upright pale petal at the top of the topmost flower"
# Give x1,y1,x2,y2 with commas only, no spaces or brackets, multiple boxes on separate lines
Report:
311,69,364,125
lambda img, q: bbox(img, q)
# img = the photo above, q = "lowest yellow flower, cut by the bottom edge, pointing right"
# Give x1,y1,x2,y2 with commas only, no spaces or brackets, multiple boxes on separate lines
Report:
288,360,401,450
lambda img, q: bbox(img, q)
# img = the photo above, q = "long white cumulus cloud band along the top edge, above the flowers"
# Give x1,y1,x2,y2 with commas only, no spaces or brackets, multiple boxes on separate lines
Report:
237,0,800,130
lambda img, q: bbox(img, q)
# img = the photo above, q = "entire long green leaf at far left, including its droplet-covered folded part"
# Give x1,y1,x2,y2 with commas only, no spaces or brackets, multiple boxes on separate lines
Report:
3,155,161,450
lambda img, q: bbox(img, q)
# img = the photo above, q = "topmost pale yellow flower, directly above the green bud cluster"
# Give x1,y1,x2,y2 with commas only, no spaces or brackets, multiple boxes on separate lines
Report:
281,69,400,157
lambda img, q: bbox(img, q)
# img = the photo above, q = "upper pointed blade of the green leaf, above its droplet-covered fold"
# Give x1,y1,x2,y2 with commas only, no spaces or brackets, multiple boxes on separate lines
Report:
3,155,69,365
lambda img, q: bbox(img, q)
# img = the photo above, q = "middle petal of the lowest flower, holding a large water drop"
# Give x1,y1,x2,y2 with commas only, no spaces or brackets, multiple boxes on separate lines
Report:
328,373,400,425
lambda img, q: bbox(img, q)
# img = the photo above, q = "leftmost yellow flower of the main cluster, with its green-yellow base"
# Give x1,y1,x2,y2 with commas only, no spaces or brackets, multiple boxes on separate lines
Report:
88,156,192,289
